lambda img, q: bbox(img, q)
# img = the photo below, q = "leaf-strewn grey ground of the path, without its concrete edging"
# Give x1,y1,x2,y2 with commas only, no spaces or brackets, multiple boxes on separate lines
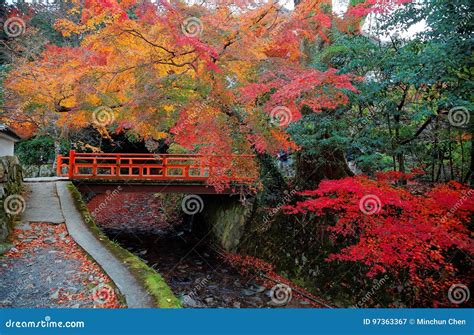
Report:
0,222,122,308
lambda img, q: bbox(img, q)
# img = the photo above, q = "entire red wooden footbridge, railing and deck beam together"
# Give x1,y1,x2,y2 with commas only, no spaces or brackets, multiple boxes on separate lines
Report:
56,150,256,193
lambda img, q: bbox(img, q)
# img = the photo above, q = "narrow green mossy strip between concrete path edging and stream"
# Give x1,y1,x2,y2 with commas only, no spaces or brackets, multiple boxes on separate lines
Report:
68,183,181,308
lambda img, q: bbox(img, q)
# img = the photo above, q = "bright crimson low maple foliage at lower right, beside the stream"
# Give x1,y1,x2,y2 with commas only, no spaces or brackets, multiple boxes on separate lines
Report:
286,175,474,305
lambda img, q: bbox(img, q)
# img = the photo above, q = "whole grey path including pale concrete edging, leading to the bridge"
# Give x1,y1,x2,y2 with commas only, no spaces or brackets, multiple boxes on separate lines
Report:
0,179,152,307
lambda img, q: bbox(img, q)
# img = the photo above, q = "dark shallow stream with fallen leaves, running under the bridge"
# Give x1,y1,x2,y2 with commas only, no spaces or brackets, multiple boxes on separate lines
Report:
88,193,311,308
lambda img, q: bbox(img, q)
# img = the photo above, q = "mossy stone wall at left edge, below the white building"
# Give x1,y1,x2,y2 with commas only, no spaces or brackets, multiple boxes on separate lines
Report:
0,156,24,249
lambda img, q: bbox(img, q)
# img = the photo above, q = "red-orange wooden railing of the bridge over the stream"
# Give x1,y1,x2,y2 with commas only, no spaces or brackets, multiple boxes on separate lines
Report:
56,150,255,182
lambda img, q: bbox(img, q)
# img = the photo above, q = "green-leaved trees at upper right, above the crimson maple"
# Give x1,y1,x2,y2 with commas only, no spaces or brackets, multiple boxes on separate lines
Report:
290,0,474,181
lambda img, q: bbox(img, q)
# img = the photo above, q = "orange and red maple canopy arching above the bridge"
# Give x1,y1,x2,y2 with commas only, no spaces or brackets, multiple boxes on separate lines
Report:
2,0,355,189
